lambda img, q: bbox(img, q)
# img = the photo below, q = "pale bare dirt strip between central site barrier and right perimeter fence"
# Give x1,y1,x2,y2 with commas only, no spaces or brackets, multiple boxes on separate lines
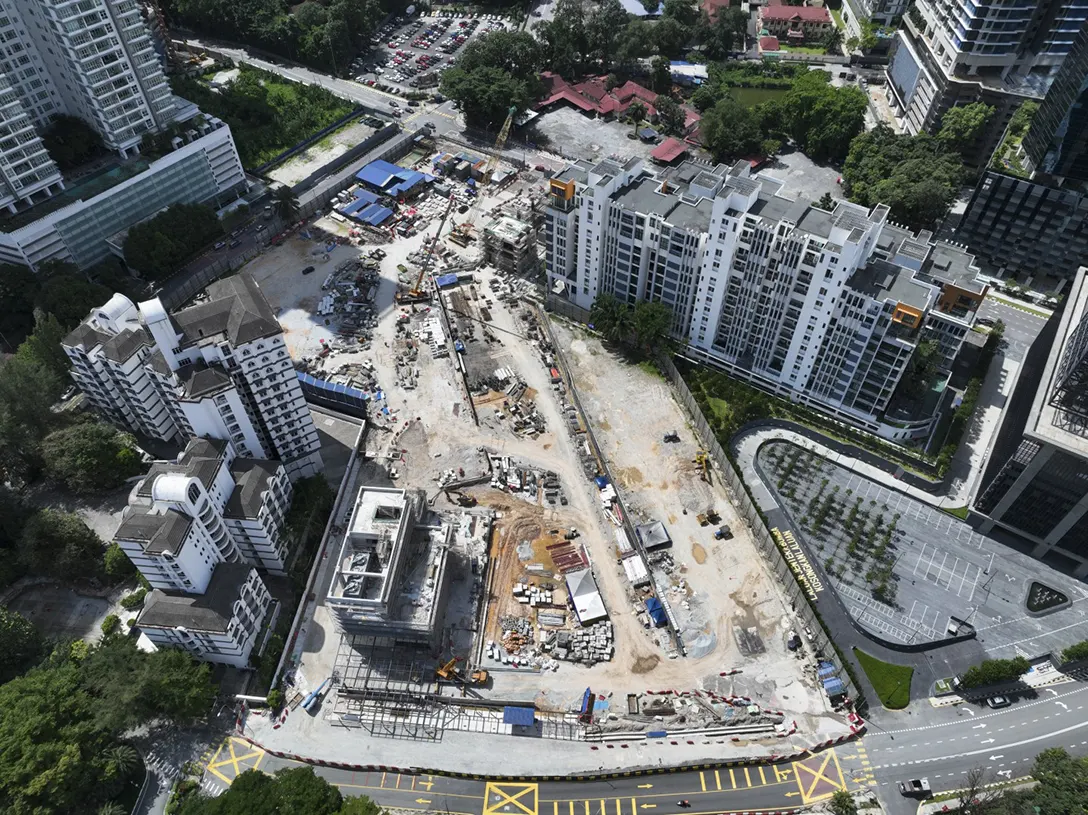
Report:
553,321,824,712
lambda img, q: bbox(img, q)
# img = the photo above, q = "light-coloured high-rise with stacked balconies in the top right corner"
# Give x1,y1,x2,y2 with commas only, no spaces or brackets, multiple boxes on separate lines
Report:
888,0,1088,164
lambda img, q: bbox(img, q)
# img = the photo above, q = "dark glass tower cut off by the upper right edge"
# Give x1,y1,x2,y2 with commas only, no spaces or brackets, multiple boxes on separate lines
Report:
1024,22,1088,185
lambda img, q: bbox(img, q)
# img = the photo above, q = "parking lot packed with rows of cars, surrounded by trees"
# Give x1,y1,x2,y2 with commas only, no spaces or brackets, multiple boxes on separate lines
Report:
351,13,514,99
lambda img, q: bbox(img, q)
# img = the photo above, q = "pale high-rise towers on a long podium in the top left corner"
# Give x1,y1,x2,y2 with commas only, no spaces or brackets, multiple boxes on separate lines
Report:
0,0,247,269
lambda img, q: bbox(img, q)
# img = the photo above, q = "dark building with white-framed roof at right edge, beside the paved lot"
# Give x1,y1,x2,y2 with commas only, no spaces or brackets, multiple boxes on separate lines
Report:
975,267,1088,577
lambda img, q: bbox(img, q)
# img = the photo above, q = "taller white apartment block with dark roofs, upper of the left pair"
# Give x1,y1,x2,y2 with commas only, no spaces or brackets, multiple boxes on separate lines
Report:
62,274,322,480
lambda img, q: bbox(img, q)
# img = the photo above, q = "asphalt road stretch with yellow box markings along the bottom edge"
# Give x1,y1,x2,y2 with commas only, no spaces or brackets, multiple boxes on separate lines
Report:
206,738,875,815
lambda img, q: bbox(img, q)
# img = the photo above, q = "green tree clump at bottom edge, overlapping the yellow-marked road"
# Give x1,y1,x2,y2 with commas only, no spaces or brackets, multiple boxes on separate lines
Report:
178,767,381,815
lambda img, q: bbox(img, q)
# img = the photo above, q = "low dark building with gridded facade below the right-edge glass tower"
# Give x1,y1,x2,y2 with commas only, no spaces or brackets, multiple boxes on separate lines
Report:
956,170,1088,279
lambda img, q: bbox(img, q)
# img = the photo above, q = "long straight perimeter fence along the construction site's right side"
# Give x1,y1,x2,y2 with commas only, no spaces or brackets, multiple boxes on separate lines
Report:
659,356,863,703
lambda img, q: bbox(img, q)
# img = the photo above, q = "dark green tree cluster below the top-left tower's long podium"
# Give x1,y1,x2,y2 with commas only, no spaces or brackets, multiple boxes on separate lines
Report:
124,203,223,280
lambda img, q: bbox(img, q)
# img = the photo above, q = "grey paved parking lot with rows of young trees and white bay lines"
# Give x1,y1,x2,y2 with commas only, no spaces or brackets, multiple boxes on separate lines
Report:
759,443,1088,658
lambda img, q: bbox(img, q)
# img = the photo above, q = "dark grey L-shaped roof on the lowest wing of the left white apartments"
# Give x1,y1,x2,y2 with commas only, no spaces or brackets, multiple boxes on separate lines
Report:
137,564,254,633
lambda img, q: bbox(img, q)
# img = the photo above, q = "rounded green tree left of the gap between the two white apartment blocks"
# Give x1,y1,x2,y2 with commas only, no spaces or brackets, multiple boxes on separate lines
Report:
41,421,144,492
